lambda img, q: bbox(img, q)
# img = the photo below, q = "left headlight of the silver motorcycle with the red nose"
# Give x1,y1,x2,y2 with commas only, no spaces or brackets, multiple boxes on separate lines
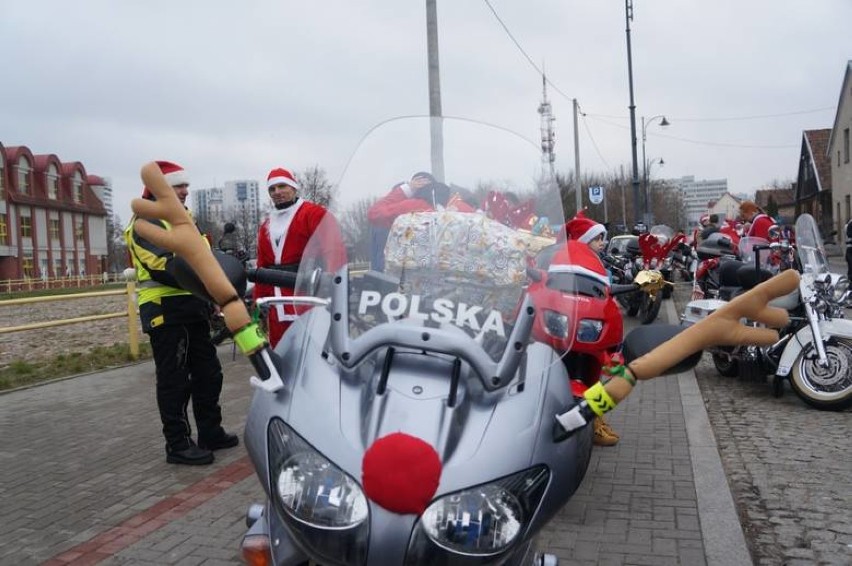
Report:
267,419,370,564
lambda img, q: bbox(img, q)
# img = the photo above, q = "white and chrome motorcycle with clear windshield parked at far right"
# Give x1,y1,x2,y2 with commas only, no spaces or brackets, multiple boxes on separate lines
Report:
681,214,852,411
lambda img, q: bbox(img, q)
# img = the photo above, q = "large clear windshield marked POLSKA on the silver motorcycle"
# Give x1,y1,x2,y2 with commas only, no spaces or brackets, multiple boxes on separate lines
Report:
296,116,571,372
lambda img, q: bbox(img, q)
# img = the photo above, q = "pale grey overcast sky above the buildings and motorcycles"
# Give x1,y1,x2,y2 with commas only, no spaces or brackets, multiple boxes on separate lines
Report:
0,0,852,221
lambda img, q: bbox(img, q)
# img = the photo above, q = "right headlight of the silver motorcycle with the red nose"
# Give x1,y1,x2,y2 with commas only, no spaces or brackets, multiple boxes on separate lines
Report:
406,466,550,564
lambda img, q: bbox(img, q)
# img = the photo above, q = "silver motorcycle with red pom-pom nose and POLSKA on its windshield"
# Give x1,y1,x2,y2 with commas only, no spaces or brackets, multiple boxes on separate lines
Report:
231,117,700,566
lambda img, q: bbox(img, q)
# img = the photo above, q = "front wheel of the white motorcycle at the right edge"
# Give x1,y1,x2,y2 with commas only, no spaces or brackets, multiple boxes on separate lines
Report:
790,340,852,411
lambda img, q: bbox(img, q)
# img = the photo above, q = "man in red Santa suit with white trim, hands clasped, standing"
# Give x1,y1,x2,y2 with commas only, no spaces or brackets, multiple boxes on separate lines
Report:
253,167,326,348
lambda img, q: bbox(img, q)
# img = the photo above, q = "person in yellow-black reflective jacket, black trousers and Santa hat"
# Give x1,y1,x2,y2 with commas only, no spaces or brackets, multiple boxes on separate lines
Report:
124,161,239,465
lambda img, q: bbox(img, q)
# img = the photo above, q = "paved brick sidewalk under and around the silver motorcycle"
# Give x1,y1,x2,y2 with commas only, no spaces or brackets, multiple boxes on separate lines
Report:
0,311,751,566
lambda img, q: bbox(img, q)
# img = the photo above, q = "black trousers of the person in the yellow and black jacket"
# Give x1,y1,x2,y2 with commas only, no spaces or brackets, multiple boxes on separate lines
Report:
148,321,225,451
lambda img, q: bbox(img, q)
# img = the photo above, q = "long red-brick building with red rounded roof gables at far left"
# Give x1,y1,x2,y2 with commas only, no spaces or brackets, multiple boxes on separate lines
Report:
0,143,107,280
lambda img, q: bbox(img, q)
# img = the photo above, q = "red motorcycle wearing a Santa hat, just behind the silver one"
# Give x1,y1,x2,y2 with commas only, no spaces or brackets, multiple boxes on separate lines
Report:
529,240,639,386
